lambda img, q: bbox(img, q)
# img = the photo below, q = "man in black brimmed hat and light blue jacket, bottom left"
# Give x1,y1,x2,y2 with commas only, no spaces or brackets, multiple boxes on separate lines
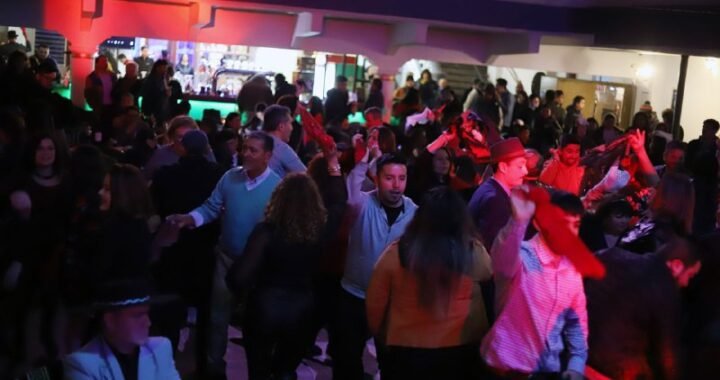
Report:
64,279,180,380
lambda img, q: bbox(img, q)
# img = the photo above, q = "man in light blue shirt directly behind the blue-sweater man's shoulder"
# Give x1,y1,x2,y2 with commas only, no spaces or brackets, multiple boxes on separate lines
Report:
263,104,307,178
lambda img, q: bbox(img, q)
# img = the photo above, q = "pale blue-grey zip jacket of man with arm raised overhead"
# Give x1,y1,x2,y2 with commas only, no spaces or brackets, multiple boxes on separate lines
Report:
342,162,417,299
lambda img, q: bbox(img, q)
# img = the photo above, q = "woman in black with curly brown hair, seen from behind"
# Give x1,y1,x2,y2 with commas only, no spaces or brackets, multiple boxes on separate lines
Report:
227,160,346,380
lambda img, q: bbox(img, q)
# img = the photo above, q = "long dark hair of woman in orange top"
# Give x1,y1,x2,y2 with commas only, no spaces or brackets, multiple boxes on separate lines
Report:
399,186,477,316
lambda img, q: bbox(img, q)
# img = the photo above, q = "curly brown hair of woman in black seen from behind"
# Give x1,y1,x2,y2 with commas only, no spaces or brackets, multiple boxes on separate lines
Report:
265,173,327,243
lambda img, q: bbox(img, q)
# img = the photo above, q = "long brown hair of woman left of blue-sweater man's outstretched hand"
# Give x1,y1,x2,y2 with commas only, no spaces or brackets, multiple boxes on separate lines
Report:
109,164,153,218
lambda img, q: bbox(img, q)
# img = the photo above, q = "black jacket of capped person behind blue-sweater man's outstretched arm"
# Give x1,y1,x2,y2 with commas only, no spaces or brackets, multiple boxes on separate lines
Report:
150,155,223,299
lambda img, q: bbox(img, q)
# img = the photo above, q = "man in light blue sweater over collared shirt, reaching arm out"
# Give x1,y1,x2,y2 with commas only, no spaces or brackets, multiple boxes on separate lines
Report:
168,132,280,378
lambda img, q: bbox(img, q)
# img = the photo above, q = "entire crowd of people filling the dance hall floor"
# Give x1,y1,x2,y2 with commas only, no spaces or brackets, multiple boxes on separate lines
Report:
0,40,720,380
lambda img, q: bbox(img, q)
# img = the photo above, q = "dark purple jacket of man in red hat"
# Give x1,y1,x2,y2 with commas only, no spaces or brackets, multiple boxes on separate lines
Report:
468,179,512,252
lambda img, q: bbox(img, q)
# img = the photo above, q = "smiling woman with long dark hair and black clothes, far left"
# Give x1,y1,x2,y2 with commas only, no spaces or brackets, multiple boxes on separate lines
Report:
7,133,72,362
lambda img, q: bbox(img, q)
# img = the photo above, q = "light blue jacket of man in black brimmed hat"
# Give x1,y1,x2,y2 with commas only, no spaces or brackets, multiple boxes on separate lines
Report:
63,337,180,380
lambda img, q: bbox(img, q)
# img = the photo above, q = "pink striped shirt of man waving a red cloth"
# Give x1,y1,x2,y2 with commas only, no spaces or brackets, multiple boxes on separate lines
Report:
481,219,588,374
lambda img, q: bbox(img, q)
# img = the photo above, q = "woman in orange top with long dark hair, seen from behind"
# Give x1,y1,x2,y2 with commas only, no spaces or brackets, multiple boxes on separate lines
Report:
366,187,492,380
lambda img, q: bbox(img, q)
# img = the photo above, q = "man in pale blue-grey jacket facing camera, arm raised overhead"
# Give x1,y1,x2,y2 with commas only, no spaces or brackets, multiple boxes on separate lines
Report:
333,150,417,380
